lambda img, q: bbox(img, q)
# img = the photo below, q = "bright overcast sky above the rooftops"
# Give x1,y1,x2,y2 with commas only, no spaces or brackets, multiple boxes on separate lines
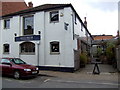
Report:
25,0,119,36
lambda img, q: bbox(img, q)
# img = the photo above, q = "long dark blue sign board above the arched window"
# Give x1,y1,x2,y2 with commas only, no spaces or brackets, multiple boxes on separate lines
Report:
15,35,40,42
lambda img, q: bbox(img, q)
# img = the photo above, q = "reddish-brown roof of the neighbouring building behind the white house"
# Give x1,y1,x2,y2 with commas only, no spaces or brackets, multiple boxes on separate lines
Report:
0,2,28,16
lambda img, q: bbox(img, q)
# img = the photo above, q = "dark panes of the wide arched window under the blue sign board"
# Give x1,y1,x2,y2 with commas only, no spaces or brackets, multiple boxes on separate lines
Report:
20,42,35,54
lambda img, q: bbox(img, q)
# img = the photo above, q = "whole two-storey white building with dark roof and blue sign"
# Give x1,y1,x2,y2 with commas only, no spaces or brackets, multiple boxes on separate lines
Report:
0,4,93,71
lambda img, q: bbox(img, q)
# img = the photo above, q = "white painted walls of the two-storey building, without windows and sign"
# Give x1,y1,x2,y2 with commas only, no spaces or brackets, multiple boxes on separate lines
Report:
0,7,92,67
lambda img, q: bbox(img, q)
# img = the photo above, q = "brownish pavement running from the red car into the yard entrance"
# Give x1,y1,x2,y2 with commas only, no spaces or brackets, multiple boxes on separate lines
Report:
40,64,119,82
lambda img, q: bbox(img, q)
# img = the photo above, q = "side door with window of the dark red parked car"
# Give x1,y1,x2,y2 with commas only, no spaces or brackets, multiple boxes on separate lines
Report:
1,59,12,75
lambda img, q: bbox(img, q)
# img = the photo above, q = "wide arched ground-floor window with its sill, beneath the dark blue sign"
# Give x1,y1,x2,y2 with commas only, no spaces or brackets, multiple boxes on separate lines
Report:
19,42,36,55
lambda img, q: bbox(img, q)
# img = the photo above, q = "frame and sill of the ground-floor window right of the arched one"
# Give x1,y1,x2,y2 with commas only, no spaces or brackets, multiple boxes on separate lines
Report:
50,41,60,55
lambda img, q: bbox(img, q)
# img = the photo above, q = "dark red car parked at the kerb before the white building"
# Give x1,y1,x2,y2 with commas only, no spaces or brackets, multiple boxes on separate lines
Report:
0,58,39,79
